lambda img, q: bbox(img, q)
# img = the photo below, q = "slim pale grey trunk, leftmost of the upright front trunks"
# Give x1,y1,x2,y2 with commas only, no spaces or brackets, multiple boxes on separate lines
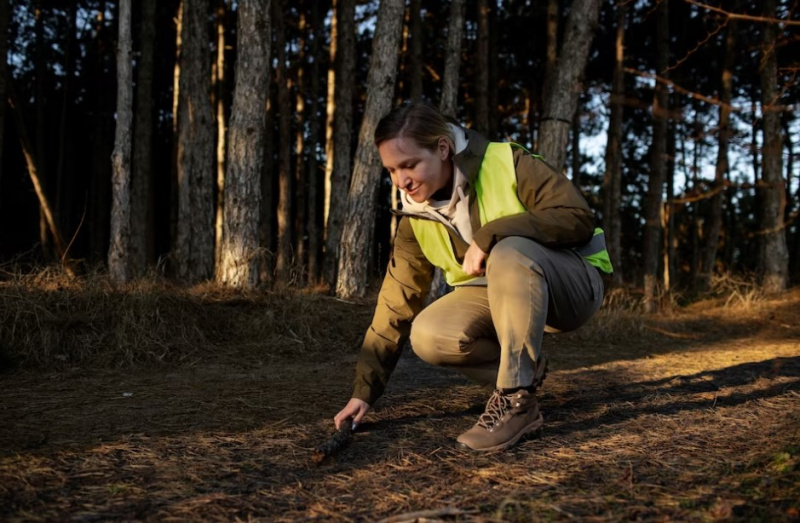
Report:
108,0,133,284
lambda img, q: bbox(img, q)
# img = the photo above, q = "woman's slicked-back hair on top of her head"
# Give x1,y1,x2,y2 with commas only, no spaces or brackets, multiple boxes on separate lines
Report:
374,102,458,154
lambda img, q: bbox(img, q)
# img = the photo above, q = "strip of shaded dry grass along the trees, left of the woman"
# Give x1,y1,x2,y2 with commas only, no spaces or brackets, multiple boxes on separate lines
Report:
0,272,370,368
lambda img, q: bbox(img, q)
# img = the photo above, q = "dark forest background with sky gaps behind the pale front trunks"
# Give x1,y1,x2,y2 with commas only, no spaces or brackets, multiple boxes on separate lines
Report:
0,0,800,302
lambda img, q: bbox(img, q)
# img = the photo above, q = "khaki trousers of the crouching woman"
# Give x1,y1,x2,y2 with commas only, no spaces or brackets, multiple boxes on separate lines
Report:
411,236,603,388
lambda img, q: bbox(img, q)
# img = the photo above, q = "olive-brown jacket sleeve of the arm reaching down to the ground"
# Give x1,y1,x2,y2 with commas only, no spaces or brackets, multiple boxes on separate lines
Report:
353,217,433,405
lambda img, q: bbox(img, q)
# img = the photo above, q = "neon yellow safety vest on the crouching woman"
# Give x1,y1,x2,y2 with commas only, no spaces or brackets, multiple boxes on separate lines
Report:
411,143,612,286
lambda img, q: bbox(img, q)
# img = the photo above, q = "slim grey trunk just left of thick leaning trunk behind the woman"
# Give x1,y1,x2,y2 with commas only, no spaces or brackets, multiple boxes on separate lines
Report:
325,0,354,288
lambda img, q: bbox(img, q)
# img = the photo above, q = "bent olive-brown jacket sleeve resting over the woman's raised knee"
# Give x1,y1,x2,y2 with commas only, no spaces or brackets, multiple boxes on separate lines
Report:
473,149,594,252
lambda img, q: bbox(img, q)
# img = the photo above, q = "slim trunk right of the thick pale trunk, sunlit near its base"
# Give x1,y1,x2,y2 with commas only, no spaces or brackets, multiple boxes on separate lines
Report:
272,0,292,285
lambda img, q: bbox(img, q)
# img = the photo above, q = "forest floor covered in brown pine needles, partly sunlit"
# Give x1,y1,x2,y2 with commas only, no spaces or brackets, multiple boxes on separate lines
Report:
0,278,800,522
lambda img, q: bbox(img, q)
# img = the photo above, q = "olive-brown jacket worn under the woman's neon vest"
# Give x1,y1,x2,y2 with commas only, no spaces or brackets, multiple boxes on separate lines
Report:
353,130,594,405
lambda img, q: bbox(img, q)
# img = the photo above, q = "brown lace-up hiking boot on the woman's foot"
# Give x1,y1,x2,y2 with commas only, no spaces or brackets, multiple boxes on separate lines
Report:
457,389,544,451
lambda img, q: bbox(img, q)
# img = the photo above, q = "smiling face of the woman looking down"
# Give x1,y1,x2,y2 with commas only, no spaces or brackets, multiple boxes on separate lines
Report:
378,137,453,203
